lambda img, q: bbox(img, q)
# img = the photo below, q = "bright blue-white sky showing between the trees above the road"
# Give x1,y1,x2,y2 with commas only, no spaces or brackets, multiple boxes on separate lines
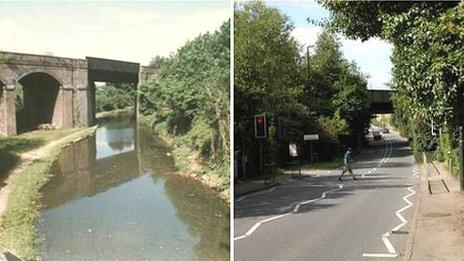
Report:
266,1,393,89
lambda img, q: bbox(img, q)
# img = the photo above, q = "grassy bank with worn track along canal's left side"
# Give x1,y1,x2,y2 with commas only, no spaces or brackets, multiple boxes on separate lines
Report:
0,127,96,260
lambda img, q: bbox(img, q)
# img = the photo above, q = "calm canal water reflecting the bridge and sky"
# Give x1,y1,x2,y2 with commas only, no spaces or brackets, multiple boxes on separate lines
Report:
37,122,230,260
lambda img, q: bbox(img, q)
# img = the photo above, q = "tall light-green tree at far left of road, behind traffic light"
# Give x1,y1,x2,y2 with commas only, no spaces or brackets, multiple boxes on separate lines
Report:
234,1,308,142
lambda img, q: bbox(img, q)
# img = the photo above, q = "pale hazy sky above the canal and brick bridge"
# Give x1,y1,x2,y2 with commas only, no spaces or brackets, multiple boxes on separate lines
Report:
0,1,230,65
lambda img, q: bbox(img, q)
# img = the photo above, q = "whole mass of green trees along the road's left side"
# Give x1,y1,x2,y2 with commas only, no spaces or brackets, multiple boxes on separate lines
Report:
234,1,370,177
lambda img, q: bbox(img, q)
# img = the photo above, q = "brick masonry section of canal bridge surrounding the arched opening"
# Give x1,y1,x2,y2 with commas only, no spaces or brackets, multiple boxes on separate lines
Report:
0,52,89,135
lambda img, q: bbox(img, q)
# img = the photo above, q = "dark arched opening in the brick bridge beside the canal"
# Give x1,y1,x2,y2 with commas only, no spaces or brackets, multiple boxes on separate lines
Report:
15,70,62,133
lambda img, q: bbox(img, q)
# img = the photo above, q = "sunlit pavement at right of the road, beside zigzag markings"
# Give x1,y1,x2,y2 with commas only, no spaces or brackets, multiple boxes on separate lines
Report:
405,159,464,260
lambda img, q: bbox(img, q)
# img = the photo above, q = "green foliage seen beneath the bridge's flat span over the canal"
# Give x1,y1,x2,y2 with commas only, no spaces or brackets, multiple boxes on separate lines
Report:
95,83,137,112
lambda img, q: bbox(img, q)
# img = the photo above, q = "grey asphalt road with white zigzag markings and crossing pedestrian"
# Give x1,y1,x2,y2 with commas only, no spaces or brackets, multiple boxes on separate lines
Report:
234,134,420,260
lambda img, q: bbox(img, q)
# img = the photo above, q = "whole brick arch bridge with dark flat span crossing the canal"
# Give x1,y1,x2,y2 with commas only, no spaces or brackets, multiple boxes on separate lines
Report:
0,52,156,135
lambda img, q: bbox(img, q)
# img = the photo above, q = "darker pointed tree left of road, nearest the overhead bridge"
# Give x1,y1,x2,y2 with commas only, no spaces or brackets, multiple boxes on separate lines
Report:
305,31,370,155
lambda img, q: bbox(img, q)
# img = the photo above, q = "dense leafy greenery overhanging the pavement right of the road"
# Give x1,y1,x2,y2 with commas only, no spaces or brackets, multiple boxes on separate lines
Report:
322,1,464,173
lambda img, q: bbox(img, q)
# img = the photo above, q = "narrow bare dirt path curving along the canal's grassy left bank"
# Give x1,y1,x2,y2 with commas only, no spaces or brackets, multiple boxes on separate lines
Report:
0,127,96,217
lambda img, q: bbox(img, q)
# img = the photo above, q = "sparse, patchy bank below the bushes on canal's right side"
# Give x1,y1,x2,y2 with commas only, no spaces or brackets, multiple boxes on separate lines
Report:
139,116,230,201
